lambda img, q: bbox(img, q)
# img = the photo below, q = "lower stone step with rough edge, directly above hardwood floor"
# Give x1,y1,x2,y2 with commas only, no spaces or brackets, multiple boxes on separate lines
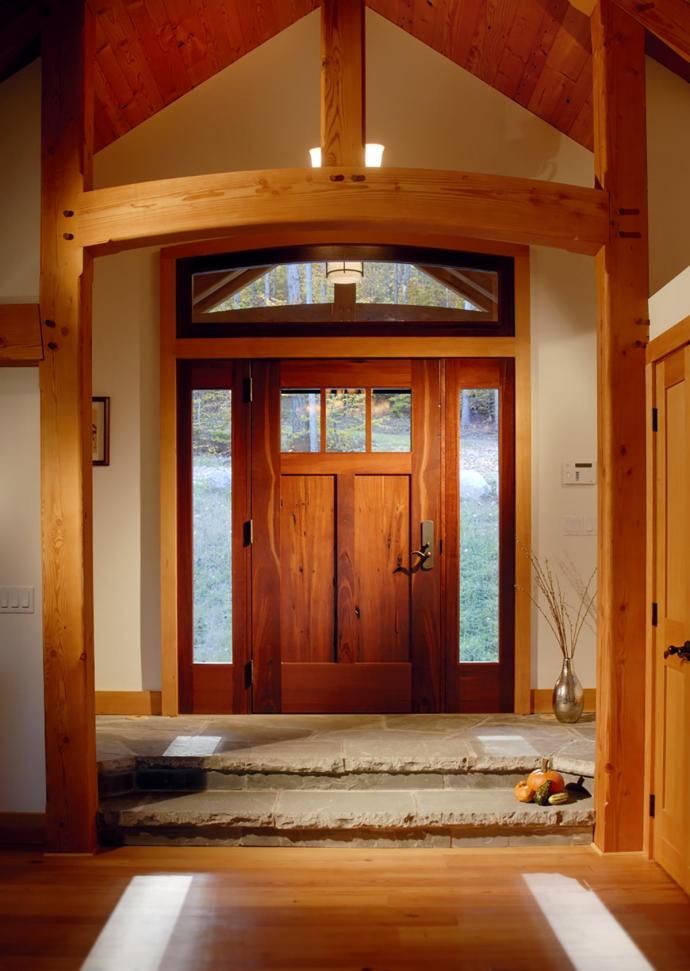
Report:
99,789,594,847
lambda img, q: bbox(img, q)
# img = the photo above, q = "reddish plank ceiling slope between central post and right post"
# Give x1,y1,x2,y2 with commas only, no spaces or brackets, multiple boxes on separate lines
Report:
368,0,592,148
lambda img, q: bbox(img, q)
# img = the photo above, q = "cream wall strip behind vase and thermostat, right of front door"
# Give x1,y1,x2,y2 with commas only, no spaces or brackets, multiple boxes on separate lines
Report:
531,247,597,688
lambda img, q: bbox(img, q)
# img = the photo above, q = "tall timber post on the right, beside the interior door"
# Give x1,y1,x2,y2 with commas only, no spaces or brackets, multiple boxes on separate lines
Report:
592,0,649,851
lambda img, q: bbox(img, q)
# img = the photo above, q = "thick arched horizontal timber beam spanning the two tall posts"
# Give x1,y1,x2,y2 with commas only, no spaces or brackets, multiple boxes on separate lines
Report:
68,168,609,255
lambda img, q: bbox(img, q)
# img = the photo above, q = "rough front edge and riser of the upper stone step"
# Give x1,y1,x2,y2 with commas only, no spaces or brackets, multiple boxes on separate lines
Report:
99,752,594,798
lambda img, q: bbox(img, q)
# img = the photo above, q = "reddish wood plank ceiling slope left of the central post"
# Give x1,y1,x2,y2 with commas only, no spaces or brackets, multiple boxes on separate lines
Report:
87,0,318,150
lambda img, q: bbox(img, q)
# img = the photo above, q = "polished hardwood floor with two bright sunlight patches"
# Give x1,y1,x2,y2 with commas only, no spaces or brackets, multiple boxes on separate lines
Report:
0,847,690,971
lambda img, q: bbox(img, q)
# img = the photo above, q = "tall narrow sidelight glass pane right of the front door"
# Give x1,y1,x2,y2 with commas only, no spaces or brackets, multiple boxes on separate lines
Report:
460,388,499,663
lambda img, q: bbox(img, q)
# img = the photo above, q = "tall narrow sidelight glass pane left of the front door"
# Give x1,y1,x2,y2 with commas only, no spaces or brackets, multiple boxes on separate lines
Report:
192,388,232,664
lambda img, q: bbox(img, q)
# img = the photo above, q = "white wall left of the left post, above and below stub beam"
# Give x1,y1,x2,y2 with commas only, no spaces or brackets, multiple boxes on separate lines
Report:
0,62,45,812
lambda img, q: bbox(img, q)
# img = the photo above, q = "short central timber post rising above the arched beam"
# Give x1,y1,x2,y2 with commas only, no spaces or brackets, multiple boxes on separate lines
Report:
321,0,366,165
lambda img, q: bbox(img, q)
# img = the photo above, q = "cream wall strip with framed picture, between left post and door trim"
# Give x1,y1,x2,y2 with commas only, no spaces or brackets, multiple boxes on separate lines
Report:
93,250,160,691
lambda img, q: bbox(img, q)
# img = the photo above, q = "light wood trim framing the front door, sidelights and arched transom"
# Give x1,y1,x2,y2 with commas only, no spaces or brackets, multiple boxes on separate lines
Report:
160,239,532,715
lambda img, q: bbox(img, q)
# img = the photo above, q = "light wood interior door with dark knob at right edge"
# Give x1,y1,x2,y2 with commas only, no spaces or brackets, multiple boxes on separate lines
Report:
653,347,690,893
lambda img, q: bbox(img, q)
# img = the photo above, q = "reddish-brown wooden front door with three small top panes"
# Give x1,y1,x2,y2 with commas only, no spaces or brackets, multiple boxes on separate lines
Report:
252,360,441,712
